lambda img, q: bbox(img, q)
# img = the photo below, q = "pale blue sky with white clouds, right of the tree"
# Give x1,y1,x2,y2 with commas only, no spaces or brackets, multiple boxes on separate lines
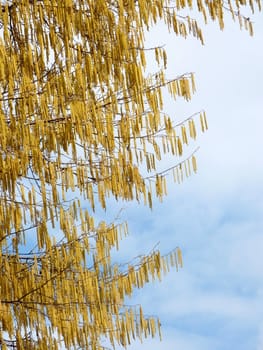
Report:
106,7,263,350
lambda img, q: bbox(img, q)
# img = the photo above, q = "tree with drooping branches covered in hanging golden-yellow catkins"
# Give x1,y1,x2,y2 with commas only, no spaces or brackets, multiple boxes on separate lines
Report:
0,0,260,350
